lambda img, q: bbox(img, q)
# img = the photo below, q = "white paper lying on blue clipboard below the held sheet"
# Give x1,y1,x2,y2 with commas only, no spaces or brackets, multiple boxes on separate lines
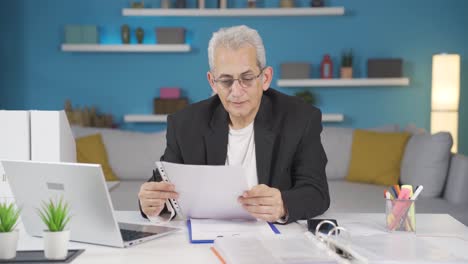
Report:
190,219,274,240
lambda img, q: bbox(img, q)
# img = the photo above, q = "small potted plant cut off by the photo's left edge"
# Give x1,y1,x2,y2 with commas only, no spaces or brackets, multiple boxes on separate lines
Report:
0,202,21,259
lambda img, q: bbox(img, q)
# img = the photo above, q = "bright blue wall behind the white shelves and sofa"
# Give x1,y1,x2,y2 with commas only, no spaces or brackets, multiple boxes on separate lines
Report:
0,0,468,153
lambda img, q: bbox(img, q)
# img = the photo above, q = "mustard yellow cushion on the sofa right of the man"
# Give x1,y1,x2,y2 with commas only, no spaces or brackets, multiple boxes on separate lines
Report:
346,129,410,186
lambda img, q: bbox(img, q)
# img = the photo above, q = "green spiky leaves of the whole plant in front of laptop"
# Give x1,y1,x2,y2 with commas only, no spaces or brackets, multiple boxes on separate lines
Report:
37,198,71,232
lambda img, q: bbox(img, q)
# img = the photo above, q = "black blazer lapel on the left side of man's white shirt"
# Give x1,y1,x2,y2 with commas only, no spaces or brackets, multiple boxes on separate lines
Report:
204,104,229,165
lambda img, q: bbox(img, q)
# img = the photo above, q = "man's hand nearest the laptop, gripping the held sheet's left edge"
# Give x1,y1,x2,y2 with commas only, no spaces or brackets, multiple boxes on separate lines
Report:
138,182,179,216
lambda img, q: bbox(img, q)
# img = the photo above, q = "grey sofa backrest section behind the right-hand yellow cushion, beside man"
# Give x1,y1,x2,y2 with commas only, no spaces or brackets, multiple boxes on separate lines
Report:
321,124,400,180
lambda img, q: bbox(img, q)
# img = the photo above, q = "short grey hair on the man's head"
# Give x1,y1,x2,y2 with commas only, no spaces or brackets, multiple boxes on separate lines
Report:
208,25,266,70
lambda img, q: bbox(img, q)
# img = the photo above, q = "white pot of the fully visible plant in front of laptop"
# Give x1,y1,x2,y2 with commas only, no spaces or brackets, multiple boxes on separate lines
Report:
44,230,70,259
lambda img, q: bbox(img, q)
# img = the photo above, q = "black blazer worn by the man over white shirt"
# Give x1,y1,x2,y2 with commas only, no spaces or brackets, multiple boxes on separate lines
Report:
143,88,330,222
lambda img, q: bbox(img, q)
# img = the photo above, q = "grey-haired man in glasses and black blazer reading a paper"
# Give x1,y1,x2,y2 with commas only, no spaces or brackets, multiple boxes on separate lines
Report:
138,26,330,223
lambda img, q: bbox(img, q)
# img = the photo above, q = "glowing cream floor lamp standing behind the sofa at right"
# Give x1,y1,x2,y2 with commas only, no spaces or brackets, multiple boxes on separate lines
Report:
431,54,460,153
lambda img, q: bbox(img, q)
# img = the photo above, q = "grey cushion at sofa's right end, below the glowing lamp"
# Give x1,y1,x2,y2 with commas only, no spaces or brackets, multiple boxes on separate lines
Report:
400,132,453,197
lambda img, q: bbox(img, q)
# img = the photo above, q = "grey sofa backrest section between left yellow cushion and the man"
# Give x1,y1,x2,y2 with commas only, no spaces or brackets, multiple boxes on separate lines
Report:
72,126,166,180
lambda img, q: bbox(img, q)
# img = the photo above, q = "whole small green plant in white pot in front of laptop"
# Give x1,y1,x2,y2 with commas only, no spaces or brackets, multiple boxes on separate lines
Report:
38,199,71,259
